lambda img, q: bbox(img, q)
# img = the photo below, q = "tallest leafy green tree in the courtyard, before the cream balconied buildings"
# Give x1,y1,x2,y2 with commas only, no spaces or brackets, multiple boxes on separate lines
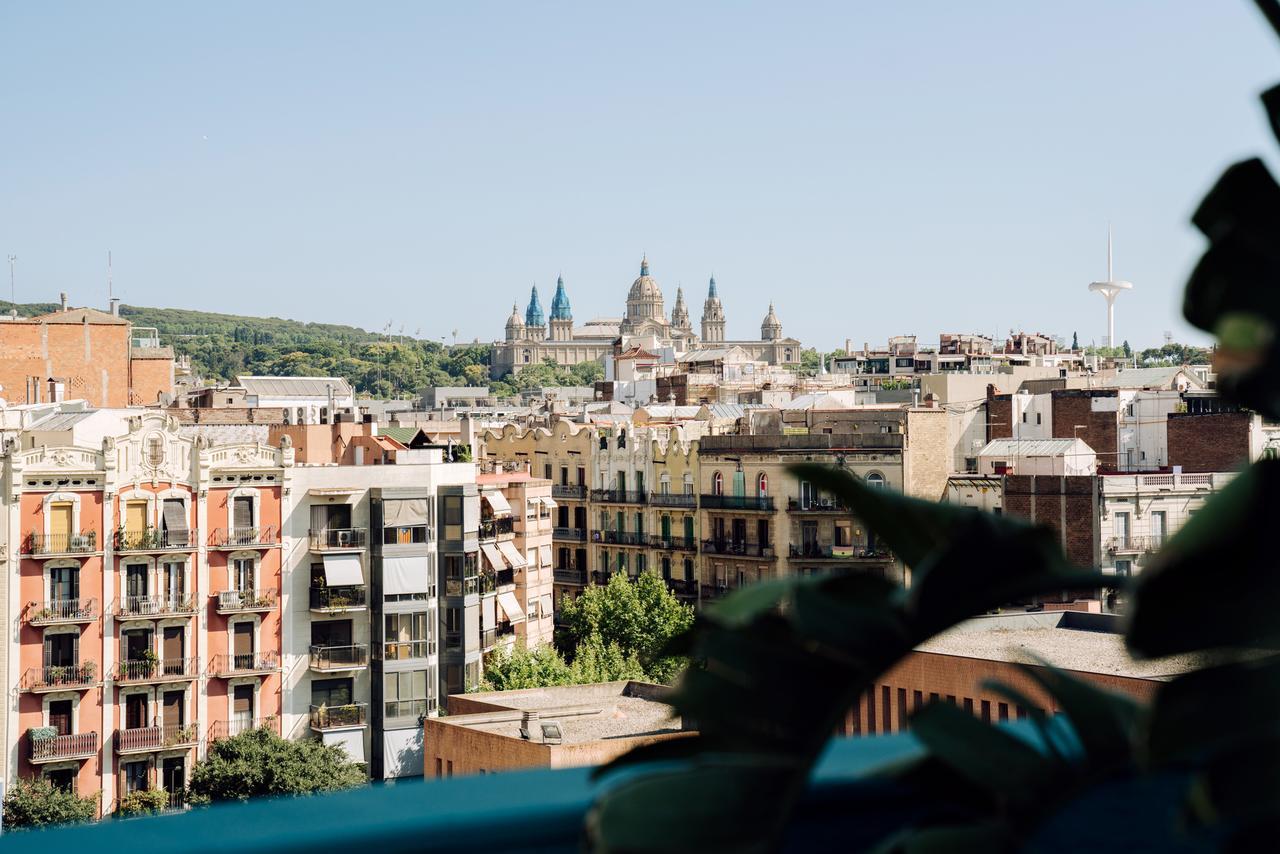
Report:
558,572,694,682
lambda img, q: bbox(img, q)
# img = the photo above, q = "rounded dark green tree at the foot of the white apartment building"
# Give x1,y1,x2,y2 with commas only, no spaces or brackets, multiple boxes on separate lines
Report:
189,729,369,803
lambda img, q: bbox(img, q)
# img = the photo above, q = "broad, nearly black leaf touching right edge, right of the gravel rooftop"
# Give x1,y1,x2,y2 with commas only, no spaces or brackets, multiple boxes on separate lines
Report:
1128,460,1280,656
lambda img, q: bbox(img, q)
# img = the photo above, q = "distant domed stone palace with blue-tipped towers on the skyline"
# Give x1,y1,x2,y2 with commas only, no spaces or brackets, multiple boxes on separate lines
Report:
492,259,801,378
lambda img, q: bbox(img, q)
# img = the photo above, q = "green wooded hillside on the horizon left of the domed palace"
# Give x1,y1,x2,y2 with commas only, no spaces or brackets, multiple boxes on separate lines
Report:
0,301,602,397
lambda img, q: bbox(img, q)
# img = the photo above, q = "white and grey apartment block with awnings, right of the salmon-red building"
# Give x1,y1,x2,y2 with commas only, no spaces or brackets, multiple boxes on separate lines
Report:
283,448,480,780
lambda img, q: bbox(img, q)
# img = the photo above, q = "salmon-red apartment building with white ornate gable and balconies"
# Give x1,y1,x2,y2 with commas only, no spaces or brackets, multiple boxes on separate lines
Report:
3,411,293,812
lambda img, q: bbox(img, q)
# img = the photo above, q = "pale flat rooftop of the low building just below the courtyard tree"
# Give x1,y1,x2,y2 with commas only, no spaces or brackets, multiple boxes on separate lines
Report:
439,681,682,744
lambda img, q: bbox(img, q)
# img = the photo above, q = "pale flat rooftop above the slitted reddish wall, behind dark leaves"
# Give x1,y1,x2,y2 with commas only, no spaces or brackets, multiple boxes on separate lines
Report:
916,611,1206,680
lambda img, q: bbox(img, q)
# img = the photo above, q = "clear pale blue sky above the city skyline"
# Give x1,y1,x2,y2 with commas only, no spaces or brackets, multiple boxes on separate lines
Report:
0,0,1280,347
